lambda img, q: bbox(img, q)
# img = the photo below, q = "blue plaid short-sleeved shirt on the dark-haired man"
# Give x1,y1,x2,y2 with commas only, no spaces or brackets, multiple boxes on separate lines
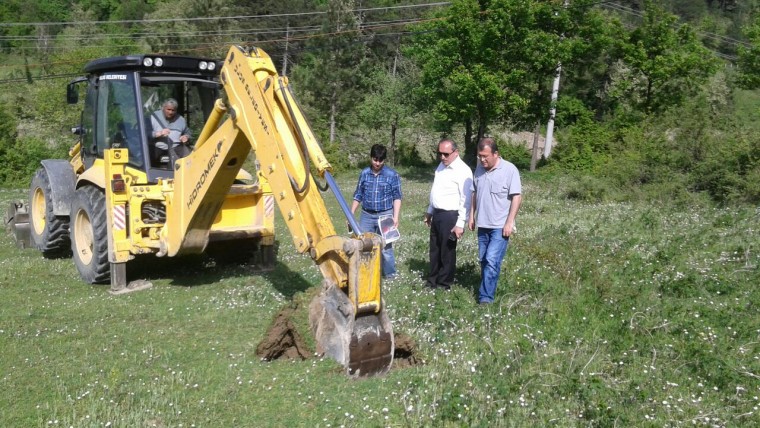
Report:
354,166,401,213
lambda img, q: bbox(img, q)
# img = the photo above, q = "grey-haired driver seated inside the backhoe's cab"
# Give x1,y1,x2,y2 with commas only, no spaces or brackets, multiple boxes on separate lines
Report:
150,98,192,158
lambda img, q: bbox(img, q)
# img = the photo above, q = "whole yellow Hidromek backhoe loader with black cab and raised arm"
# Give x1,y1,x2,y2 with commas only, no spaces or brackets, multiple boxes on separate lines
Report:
6,47,394,376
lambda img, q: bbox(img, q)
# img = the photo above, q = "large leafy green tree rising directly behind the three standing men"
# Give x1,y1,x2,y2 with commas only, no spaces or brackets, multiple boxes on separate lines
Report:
409,0,585,161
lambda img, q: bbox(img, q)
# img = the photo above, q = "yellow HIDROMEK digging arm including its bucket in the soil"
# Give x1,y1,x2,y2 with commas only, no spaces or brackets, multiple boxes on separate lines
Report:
161,47,393,376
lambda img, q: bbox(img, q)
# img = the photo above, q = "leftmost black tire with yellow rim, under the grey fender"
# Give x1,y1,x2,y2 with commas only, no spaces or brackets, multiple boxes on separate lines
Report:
29,168,70,258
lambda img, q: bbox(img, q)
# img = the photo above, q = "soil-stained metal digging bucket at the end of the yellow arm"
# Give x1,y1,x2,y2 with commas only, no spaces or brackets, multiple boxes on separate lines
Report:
309,286,394,377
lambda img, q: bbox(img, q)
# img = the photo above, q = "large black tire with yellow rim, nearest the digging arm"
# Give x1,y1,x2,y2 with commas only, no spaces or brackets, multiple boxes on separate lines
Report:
71,186,111,284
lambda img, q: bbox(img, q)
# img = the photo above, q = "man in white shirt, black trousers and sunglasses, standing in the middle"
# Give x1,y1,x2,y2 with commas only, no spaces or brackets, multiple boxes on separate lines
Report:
425,139,473,290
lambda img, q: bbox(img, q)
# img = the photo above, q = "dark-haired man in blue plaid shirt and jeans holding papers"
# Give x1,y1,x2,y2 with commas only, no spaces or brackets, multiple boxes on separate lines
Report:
351,144,401,279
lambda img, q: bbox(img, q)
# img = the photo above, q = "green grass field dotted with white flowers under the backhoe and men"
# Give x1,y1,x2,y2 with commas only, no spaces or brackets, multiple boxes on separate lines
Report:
0,171,760,427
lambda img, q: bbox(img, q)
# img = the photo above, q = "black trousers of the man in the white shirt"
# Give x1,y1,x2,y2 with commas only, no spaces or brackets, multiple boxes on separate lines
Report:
427,210,458,289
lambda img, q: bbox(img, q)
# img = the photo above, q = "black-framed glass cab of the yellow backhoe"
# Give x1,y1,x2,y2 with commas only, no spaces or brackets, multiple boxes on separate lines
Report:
67,55,221,182
